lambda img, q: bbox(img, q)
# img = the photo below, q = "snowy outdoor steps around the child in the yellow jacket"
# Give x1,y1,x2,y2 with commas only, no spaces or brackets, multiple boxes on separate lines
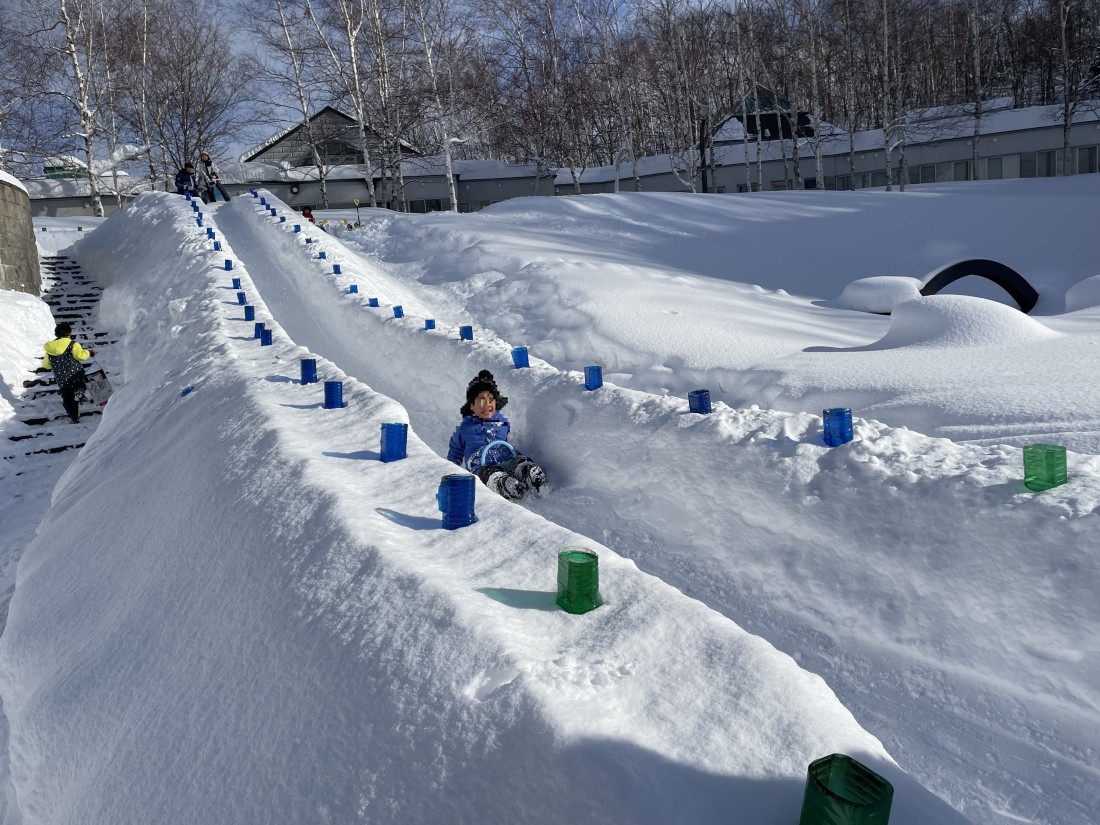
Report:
2,255,116,475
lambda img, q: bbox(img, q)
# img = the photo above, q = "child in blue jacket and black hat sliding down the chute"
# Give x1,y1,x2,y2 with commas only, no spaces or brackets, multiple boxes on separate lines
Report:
447,370,547,501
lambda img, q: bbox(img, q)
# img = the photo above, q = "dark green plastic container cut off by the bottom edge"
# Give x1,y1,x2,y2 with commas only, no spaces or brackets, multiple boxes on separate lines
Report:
799,754,893,825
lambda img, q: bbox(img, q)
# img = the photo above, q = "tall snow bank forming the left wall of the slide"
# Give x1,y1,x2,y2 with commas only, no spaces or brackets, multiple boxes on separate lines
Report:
0,195,961,825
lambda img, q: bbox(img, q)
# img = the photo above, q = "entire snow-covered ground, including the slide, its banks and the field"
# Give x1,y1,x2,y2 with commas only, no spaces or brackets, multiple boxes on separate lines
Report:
0,176,1100,825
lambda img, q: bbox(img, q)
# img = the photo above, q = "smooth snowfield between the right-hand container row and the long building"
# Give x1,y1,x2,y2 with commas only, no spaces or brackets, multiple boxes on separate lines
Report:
340,175,1100,452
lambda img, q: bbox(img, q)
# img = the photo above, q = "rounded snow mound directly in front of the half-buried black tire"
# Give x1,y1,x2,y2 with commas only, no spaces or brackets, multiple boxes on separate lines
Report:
865,295,1062,350
